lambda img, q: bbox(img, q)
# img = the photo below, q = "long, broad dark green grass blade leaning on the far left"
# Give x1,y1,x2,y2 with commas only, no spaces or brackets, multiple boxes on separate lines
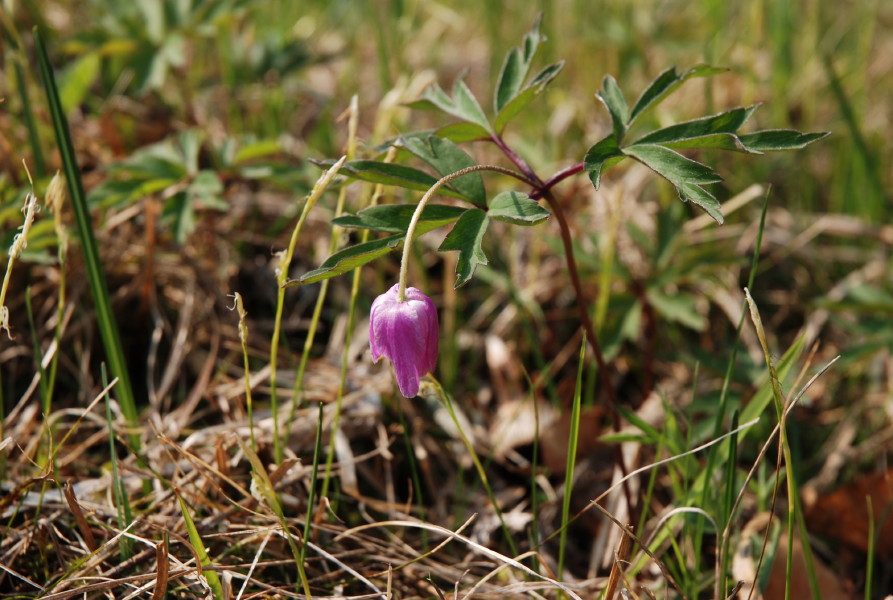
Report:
34,27,142,452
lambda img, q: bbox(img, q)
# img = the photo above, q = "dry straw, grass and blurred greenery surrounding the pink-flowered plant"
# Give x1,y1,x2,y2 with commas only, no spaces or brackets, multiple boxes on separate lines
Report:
0,0,893,598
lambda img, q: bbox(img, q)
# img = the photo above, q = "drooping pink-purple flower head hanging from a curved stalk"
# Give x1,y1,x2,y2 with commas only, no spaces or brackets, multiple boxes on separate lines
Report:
369,284,439,398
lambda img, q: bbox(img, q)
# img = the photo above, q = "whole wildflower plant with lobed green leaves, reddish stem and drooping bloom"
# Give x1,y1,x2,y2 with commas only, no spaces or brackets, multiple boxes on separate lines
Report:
286,21,827,406
